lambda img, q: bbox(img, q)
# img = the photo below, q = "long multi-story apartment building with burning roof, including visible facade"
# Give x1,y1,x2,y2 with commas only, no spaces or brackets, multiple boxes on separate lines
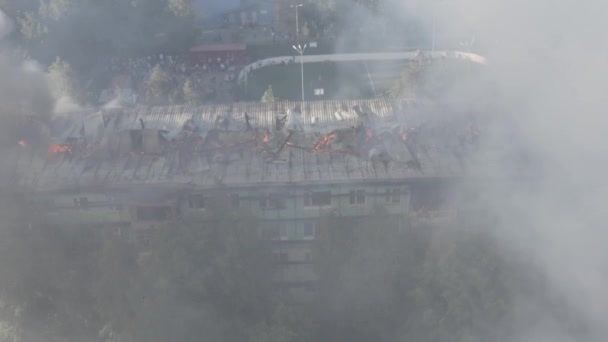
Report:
17,99,477,295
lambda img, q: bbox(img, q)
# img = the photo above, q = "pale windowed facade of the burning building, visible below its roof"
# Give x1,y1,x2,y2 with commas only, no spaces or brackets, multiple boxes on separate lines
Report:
33,180,412,301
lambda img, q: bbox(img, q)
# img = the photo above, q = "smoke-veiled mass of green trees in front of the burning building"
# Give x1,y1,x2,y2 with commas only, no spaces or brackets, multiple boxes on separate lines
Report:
0,195,584,342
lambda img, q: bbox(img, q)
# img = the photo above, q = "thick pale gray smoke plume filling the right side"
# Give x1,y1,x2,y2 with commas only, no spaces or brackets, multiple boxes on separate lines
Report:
396,0,608,341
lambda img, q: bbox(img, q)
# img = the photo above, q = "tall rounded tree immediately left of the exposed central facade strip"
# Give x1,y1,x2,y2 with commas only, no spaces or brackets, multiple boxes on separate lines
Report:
137,192,277,340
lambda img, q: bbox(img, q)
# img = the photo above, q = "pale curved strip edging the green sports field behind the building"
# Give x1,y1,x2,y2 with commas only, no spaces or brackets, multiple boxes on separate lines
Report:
238,50,488,85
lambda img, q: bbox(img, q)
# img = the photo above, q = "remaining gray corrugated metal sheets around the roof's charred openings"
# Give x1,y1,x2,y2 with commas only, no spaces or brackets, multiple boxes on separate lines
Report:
18,99,470,191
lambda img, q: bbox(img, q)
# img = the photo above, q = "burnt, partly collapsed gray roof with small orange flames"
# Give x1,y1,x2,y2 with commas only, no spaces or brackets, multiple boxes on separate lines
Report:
17,99,470,191
